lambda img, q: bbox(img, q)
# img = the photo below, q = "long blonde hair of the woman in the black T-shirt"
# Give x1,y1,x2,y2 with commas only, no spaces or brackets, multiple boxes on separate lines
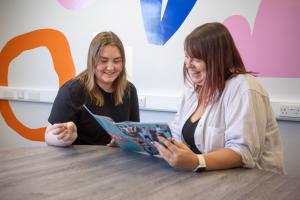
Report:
77,31,129,106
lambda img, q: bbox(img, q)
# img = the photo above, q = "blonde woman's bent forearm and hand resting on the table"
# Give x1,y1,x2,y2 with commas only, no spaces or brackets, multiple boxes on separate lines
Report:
46,121,77,146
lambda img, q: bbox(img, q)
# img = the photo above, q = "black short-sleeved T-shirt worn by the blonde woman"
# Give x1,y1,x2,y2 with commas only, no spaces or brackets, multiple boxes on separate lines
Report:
48,79,140,145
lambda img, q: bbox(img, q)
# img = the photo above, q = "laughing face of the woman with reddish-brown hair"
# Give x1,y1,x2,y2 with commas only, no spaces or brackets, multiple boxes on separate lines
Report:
184,54,206,86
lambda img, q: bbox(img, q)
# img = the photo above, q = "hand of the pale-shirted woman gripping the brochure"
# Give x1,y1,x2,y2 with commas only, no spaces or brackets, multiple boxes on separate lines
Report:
155,136,198,170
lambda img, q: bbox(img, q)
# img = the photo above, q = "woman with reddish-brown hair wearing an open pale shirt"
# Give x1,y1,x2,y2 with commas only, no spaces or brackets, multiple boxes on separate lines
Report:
156,23,284,173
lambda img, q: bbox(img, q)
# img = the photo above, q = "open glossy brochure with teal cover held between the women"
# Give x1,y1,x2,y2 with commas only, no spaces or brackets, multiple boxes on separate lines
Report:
83,105,172,155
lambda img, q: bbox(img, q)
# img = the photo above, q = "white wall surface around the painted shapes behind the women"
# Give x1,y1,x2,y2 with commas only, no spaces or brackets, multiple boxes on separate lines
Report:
0,0,300,175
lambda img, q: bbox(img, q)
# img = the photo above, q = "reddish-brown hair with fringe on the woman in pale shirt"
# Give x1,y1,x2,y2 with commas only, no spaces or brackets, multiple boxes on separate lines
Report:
183,22,250,102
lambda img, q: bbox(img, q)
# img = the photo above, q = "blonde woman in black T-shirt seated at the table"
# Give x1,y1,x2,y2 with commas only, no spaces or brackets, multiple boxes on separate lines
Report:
45,32,140,146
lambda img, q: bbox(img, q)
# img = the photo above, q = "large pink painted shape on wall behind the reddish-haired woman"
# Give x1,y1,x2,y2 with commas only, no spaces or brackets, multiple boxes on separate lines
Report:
224,0,300,78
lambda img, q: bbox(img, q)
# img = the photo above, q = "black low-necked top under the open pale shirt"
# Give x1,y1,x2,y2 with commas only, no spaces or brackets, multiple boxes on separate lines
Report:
182,117,201,154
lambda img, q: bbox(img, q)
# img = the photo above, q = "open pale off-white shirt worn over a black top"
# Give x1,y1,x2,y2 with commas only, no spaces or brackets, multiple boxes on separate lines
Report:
170,74,284,173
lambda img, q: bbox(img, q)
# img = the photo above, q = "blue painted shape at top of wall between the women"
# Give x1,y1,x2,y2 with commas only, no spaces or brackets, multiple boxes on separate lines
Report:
141,0,197,45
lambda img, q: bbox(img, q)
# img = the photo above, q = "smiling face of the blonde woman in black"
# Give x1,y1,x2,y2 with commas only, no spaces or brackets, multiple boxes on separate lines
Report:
95,45,123,92
